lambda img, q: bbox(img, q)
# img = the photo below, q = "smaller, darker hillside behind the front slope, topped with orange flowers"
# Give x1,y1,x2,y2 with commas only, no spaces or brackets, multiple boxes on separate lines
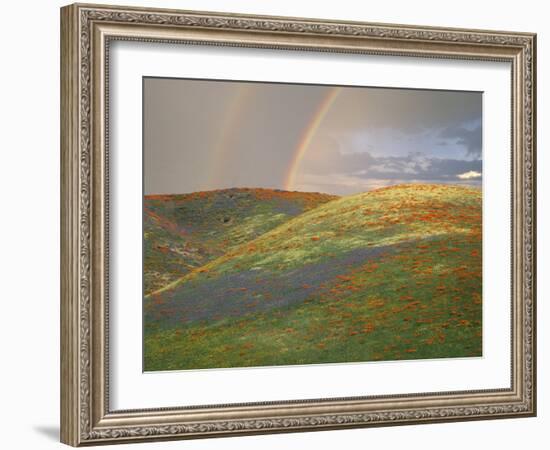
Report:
143,189,336,295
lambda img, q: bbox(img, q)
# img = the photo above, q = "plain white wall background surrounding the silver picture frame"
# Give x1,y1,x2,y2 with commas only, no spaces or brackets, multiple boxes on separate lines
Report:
0,0,550,450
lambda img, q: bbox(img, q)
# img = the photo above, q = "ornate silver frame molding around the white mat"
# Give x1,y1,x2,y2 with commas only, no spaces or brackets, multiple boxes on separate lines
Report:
61,4,536,446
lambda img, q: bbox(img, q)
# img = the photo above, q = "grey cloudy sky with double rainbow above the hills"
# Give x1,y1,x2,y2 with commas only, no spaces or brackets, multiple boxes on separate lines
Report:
144,78,482,195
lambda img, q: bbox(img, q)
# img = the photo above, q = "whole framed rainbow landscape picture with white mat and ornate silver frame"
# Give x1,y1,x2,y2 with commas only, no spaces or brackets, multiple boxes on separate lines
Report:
61,4,536,446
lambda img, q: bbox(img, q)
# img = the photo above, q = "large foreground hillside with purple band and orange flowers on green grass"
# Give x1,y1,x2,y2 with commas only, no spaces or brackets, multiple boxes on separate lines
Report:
145,185,481,370
